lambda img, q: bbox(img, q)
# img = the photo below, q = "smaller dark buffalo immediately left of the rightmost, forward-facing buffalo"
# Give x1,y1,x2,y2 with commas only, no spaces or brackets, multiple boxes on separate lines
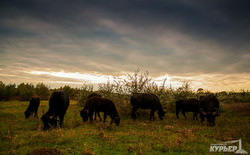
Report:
176,98,199,120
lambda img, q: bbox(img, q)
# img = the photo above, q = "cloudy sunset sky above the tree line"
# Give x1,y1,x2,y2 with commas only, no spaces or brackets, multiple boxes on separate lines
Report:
0,0,250,91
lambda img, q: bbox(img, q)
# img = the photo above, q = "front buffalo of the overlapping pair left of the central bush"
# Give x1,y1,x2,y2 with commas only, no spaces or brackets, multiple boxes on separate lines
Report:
81,96,120,126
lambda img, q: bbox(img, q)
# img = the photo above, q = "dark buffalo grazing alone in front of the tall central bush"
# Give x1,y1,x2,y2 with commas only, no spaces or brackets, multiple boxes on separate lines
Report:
130,93,165,121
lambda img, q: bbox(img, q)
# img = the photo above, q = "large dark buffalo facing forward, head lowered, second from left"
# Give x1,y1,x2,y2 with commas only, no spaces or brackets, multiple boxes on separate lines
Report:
41,91,69,130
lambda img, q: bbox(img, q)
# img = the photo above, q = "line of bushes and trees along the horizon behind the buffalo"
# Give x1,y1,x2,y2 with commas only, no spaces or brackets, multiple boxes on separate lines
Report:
0,69,250,111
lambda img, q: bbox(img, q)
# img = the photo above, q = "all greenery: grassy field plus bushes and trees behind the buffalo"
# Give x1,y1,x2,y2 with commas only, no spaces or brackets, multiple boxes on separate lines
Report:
0,70,250,154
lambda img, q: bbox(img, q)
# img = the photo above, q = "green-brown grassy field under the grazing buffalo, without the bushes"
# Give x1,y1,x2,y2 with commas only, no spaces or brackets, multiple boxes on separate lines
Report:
0,101,250,154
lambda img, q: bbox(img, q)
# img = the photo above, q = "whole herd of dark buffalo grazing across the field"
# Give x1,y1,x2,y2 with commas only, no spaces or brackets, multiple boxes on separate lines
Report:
24,91,219,130
